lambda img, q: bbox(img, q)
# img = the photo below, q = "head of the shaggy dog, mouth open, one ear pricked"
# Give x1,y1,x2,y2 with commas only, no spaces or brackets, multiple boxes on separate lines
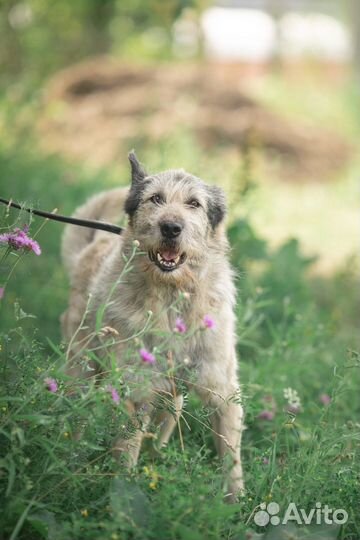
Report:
125,152,226,280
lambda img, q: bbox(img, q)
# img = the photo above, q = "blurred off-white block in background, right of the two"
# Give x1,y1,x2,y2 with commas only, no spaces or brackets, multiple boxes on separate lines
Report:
279,13,352,61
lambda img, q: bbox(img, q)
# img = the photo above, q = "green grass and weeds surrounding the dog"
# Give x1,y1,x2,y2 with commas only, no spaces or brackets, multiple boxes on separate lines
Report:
0,81,360,540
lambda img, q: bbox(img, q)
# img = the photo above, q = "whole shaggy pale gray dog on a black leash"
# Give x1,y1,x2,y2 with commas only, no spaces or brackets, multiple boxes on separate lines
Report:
62,152,243,500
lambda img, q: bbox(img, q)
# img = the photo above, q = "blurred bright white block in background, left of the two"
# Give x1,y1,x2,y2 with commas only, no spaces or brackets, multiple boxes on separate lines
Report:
201,7,276,62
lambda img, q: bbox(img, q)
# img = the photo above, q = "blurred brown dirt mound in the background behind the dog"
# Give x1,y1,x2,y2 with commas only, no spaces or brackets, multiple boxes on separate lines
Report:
39,57,351,181
